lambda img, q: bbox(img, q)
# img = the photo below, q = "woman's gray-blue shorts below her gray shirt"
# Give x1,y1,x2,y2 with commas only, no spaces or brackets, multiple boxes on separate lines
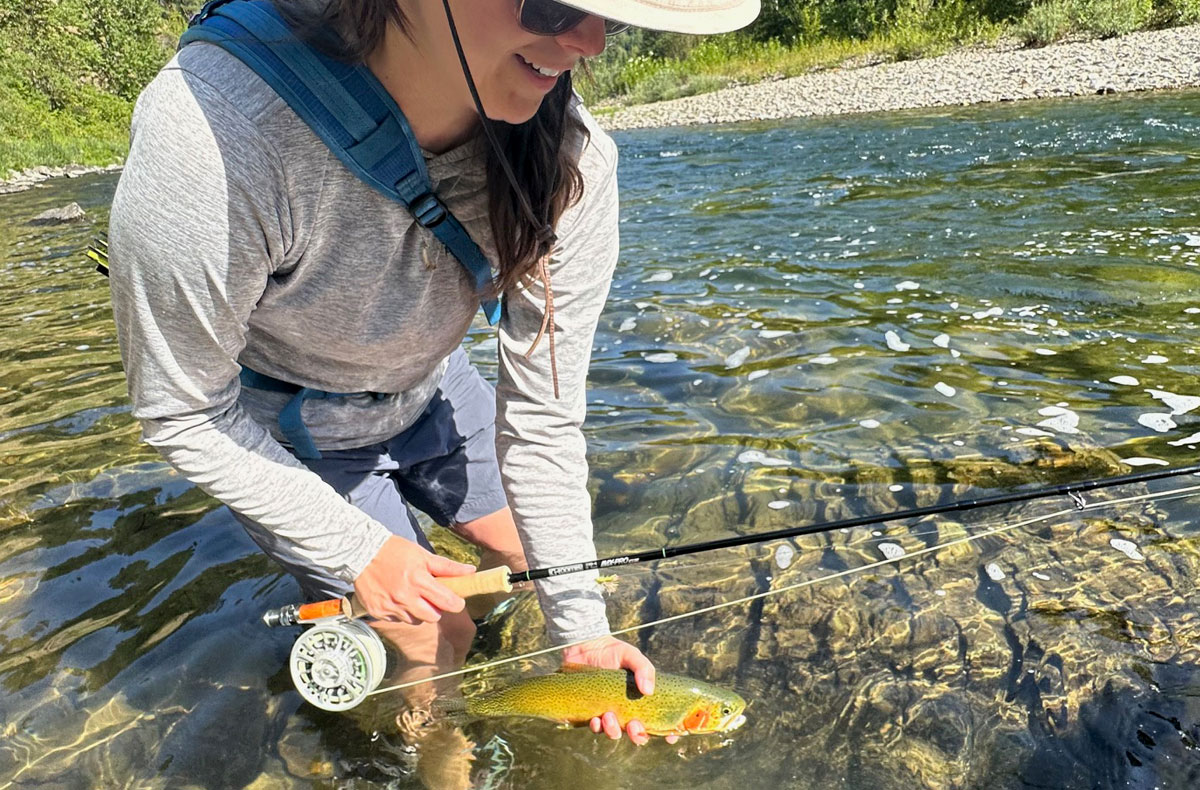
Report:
234,348,508,598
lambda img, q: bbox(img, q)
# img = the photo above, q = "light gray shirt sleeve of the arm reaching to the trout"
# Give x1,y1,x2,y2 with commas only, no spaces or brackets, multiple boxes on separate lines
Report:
497,109,619,644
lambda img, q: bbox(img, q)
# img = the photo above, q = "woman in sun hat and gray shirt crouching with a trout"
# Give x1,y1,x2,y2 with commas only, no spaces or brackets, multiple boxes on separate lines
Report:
110,0,758,743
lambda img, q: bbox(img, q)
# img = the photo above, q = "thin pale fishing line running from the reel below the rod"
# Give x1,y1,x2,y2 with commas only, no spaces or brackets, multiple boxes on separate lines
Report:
366,475,1200,696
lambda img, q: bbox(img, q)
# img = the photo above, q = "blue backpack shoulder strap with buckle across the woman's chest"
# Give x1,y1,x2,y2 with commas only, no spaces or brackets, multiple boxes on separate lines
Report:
179,0,500,324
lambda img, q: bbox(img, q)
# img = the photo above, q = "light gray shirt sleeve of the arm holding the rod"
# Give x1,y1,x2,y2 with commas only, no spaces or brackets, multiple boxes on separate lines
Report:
109,60,390,582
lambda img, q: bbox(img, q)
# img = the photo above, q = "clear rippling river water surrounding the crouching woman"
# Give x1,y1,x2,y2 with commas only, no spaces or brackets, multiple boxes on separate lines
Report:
0,92,1200,790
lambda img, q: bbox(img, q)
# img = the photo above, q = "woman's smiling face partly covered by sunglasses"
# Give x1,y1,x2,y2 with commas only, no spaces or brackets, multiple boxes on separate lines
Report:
414,0,605,124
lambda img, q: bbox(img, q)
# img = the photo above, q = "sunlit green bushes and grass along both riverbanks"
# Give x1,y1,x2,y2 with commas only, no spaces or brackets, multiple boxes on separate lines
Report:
0,0,1200,178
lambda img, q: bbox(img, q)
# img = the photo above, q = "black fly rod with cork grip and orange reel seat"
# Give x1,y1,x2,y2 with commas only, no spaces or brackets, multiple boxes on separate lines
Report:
263,465,1200,627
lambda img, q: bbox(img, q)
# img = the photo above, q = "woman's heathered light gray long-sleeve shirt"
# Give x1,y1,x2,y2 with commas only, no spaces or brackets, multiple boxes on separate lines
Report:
109,44,618,642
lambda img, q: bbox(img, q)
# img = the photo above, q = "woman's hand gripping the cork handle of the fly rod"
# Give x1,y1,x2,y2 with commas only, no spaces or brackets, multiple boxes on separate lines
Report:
354,535,475,626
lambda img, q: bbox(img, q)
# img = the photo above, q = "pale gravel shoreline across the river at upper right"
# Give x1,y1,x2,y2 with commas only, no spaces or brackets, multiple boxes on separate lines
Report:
599,25,1200,131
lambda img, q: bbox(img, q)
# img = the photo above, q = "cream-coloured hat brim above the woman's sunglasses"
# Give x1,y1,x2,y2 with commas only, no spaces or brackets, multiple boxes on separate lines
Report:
559,0,760,35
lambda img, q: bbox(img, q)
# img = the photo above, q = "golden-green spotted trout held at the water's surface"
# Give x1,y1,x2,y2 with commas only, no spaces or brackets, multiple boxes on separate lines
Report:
438,666,746,735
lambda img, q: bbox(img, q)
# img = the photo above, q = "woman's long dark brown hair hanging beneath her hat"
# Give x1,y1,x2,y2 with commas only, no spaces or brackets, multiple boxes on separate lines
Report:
275,0,587,293
